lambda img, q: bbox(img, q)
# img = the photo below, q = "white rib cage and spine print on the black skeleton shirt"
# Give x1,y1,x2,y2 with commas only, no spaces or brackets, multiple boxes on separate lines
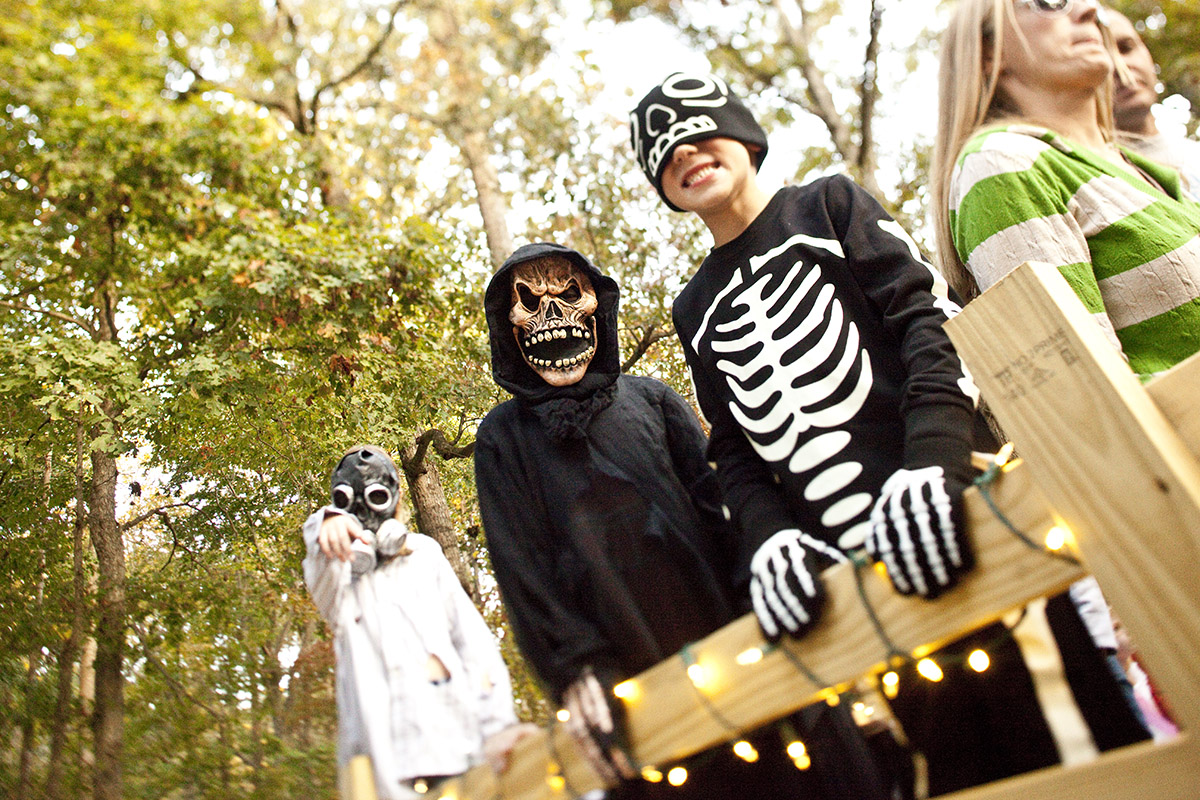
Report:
691,234,872,548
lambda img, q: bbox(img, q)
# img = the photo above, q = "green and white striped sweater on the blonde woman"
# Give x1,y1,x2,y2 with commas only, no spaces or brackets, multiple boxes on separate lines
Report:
949,125,1200,377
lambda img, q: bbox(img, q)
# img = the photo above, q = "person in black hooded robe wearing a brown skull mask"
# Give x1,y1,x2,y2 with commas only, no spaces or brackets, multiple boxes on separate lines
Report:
475,243,888,800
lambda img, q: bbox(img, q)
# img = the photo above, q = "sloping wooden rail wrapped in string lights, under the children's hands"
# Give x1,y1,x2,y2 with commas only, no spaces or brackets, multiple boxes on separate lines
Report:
433,464,1082,800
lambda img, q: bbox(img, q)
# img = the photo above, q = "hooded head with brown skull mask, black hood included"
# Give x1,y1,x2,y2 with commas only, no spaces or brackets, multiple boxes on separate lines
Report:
484,242,620,403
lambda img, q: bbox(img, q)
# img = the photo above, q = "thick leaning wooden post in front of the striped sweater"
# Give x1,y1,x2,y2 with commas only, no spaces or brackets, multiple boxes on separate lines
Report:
947,264,1200,738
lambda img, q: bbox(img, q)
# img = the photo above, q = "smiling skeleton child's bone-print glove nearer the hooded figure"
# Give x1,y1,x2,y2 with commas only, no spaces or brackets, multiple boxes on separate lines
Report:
750,528,840,642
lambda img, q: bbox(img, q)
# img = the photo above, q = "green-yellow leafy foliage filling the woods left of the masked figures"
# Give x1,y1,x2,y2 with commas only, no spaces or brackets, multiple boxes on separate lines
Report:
0,2,492,796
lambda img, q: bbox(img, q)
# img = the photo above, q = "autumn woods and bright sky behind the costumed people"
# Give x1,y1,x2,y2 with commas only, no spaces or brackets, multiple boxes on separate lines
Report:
0,0,1200,800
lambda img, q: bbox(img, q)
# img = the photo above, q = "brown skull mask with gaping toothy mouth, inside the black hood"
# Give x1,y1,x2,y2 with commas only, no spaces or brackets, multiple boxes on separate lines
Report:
509,255,598,386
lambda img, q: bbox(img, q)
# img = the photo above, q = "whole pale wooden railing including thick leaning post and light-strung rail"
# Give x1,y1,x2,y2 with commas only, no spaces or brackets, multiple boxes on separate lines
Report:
350,265,1200,800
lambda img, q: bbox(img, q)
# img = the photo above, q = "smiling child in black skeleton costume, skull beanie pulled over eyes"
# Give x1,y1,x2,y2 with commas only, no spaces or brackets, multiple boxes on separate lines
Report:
631,73,1147,794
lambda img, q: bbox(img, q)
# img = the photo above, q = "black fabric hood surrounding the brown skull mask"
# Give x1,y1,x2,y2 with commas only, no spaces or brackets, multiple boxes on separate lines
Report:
484,242,620,403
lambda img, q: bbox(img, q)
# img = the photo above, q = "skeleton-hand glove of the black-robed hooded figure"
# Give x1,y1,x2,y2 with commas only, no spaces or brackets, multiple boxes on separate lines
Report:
563,667,637,786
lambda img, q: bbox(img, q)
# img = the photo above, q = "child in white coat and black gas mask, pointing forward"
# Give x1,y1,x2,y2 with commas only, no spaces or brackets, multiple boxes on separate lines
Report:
304,446,529,800
